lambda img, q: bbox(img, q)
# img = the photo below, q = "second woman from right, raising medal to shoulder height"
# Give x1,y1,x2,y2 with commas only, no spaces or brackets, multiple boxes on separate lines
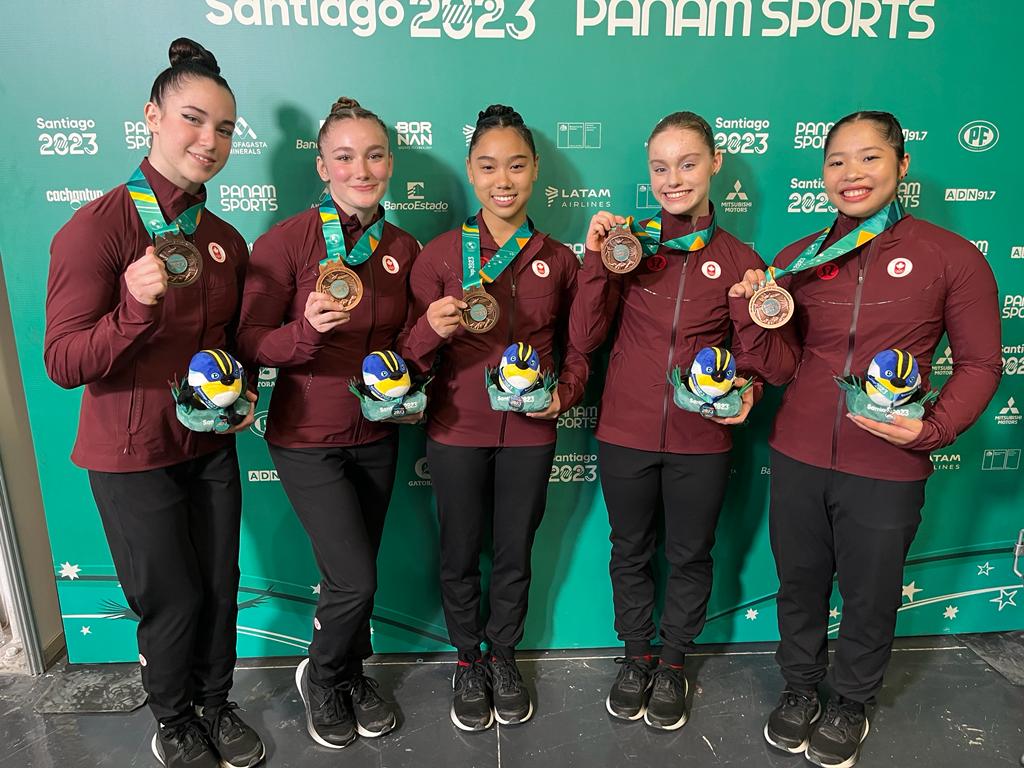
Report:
570,112,781,730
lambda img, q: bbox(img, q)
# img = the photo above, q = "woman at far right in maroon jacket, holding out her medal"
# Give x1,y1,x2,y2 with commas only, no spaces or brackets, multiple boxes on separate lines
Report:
733,112,1001,768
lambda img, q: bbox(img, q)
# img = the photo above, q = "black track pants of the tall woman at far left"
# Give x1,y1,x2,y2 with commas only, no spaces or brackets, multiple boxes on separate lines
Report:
89,446,242,725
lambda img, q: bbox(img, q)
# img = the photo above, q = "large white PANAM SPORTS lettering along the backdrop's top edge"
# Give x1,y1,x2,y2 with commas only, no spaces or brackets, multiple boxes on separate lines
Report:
577,0,935,40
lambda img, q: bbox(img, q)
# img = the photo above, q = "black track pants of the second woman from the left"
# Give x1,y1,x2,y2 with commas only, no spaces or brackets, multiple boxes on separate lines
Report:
269,435,398,686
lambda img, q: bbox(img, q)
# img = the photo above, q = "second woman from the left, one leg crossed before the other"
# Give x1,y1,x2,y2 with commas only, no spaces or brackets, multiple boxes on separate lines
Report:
239,97,419,749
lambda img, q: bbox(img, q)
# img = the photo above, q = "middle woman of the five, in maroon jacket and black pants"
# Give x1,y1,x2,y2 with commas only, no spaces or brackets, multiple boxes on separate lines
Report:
401,104,587,730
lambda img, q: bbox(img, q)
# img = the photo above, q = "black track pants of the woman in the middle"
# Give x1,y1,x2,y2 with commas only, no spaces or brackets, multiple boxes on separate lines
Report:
427,439,555,653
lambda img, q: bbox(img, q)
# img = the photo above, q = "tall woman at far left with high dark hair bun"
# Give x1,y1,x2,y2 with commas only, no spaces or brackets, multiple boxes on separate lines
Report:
43,38,264,768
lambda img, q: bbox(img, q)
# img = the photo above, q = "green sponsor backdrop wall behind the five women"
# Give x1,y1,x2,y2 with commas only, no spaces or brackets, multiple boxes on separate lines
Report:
0,0,1024,662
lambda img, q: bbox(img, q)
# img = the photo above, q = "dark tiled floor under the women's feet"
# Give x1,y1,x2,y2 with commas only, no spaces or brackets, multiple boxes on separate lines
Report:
0,637,1024,768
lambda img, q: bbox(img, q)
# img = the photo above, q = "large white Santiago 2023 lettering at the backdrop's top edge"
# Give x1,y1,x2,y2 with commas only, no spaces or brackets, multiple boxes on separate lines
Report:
206,0,537,40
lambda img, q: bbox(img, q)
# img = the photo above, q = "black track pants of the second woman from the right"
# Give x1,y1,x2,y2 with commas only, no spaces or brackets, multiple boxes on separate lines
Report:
598,442,729,664
